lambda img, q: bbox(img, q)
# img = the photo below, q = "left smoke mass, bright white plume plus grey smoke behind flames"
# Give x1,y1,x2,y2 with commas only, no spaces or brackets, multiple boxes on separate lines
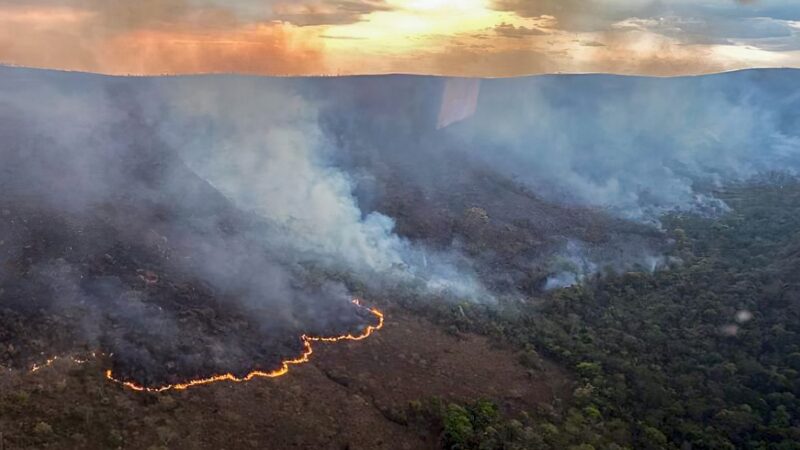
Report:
0,69,490,384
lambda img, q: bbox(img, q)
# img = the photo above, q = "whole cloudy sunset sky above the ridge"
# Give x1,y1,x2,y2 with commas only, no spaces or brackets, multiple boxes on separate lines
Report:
0,0,800,77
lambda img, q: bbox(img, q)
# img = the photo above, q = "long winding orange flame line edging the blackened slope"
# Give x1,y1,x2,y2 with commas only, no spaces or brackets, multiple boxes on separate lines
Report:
101,299,383,392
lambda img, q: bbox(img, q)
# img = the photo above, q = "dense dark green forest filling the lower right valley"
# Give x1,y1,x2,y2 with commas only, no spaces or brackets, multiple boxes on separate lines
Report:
416,176,800,449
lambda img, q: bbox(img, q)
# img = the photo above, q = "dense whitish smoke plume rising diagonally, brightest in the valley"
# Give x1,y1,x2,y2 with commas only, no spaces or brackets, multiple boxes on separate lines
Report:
152,77,487,298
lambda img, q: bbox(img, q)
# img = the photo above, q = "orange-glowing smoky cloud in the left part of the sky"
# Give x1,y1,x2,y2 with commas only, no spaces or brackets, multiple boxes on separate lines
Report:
0,0,325,74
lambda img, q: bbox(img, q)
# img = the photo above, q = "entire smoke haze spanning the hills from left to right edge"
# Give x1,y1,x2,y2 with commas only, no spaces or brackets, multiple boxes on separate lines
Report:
0,68,800,384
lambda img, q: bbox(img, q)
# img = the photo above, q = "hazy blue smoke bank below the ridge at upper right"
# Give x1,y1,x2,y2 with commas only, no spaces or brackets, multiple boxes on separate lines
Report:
445,71,800,221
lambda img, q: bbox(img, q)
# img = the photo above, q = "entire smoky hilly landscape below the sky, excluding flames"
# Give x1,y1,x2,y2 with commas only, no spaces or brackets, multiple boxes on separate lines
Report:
0,68,800,449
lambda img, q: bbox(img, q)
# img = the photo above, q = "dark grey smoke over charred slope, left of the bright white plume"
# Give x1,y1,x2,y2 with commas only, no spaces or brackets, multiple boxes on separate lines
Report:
0,71,390,384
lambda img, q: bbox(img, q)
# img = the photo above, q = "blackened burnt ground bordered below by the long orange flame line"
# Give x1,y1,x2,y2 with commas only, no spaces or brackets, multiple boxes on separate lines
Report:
0,178,383,390
